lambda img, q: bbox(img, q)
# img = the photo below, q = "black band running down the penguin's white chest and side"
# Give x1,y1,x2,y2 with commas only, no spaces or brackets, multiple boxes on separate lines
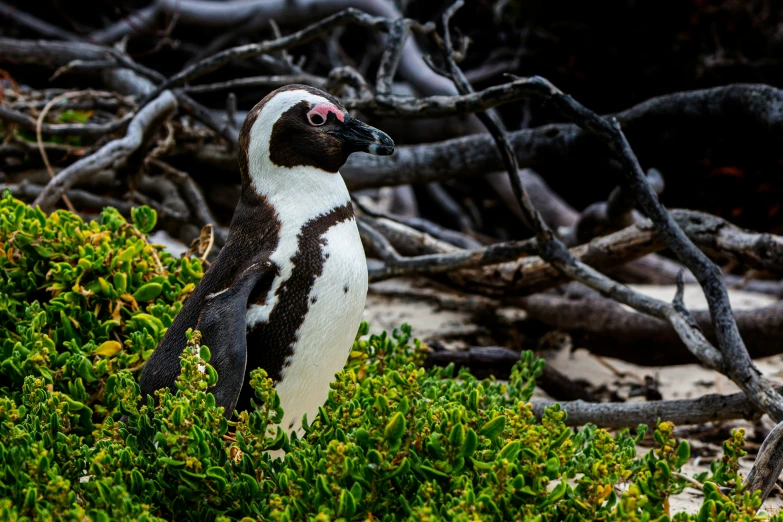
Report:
237,202,353,410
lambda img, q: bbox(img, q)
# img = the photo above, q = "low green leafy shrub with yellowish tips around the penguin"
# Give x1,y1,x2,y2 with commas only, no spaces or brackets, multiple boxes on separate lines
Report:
0,194,783,522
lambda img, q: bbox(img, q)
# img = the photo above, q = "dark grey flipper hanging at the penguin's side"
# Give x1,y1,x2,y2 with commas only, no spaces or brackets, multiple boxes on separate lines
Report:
198,263,269,418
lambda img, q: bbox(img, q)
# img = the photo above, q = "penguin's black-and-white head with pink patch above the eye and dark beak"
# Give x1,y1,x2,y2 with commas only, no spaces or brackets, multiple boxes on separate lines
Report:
239,85,394,189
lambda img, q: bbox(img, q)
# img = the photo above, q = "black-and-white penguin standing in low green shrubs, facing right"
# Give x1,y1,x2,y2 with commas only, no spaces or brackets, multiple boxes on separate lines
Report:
140,85,394,433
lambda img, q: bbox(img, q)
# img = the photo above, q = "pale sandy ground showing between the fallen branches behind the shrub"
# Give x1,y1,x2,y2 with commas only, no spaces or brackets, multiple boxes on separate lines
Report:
364,281,783,513
